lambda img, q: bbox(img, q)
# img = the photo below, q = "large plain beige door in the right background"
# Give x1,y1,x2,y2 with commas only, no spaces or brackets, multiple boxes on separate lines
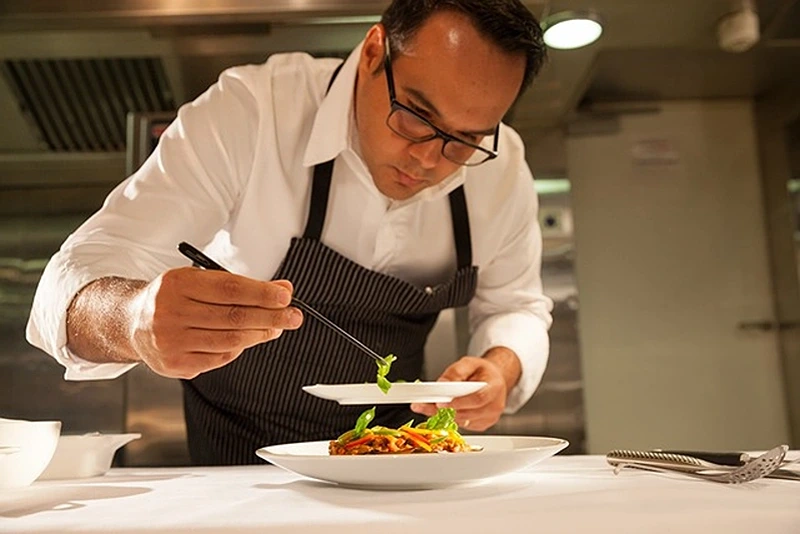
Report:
567,100,789,453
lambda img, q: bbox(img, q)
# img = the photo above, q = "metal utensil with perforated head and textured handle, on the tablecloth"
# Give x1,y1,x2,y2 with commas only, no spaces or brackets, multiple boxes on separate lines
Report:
606,445,789,484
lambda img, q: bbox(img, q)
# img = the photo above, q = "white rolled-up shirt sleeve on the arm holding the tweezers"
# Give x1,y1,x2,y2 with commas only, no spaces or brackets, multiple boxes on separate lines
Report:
26,69,258,380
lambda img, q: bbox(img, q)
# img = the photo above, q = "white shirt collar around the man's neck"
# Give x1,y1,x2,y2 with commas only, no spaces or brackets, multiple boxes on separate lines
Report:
303,41,467,210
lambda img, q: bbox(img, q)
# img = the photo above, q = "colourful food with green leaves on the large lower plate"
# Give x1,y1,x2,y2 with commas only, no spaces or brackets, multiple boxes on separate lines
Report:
328,407,480,456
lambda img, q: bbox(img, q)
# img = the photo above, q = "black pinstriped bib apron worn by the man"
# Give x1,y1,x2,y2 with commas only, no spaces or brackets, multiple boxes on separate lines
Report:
182,61,477,465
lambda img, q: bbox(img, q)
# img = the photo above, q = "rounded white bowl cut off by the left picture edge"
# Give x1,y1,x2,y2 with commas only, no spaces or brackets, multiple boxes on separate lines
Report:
0,419,61,488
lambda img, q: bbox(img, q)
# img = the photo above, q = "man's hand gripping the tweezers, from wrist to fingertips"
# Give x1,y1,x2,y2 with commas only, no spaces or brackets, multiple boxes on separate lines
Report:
130,267,303,378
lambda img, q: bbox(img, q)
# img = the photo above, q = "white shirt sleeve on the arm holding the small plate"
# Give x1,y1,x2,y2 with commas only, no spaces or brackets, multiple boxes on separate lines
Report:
469,165,553,413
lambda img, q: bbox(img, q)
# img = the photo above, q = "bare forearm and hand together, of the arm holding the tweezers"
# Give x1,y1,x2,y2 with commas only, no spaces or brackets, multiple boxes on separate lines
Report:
68,267,303,378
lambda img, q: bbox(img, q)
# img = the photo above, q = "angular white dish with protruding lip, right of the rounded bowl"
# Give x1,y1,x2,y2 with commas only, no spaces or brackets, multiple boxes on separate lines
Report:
39,432,142,480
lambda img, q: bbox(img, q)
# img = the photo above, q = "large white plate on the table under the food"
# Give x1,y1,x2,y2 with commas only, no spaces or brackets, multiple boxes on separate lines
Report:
256,436,569,490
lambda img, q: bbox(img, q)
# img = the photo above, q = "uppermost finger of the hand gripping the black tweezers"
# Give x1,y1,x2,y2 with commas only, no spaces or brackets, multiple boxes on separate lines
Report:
175,267,292,308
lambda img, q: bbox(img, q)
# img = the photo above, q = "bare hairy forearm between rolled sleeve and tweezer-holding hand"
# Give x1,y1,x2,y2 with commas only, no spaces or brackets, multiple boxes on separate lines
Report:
67,277,147,363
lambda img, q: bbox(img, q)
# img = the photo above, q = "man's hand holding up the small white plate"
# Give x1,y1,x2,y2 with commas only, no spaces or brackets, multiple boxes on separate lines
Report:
411,347,521,430
